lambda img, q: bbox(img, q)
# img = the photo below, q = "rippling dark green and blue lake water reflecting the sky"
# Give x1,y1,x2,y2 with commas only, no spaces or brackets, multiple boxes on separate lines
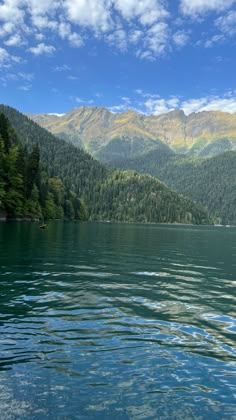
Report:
0,222,236,420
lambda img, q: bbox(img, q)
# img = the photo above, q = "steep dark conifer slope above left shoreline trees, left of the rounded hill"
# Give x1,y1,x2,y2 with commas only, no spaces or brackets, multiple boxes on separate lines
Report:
0,105,107,197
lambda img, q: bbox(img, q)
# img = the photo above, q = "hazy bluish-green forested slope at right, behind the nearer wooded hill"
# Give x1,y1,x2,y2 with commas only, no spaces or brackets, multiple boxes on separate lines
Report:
115,147,236,224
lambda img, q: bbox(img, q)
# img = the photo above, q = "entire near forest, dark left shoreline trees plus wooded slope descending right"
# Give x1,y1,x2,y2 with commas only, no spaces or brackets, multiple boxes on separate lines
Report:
0,105,209,224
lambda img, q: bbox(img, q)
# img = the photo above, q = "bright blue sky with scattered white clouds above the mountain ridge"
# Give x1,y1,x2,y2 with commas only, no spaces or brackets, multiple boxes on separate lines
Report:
0,0,236,115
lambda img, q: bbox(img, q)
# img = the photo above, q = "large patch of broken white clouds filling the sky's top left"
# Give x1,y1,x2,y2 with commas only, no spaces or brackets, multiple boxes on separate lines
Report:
0,0,171,59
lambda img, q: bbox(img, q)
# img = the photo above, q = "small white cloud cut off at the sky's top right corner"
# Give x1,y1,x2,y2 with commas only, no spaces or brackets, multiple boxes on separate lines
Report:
180,0,235,16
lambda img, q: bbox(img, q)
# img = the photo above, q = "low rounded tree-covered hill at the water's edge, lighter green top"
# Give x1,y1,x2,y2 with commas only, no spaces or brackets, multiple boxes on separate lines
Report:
89,171,208,224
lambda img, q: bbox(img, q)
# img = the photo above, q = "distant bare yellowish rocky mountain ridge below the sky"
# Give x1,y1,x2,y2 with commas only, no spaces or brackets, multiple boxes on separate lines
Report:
29,106,236,162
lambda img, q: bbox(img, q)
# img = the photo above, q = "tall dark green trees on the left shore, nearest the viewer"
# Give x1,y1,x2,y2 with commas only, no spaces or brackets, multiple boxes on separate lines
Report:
0,113,86,219
